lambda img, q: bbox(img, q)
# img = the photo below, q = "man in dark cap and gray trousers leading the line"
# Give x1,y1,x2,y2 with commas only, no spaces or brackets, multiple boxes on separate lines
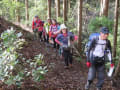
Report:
85,27,114,90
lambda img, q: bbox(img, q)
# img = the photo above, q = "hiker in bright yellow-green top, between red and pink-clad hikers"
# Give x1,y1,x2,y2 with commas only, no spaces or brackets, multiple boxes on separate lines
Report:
44,19,52,43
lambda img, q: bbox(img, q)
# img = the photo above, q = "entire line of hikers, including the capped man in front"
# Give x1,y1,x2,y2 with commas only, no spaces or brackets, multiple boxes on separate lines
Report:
32,16,114,90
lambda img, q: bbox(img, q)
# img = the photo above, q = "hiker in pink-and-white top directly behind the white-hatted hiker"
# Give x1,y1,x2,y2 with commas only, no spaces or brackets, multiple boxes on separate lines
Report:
49,19,59,48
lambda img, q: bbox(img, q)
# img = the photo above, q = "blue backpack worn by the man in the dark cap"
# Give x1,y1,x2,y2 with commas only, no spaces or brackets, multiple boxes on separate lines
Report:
85,33,100,56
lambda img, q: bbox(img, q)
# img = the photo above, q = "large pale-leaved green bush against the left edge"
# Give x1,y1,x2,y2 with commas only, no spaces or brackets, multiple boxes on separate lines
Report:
0,29,25,85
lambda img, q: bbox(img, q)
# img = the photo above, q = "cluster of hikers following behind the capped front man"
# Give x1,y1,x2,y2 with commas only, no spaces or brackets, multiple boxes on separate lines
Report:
32,16,77,69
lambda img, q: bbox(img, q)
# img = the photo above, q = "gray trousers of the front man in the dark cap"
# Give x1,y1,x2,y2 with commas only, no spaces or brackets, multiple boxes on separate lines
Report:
88,64,105,88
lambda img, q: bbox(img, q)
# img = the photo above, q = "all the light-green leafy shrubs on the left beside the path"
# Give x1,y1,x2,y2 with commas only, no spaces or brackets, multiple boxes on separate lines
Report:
0,29,47,87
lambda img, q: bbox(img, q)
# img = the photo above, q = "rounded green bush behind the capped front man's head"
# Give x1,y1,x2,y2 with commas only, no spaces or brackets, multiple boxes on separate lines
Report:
88,17,113,33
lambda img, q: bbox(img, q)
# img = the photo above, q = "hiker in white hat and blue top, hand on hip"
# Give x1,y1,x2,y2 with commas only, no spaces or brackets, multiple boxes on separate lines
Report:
55,24,78,68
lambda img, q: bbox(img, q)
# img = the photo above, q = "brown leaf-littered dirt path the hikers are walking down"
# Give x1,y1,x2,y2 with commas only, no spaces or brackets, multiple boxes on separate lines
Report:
20,41,119,90
